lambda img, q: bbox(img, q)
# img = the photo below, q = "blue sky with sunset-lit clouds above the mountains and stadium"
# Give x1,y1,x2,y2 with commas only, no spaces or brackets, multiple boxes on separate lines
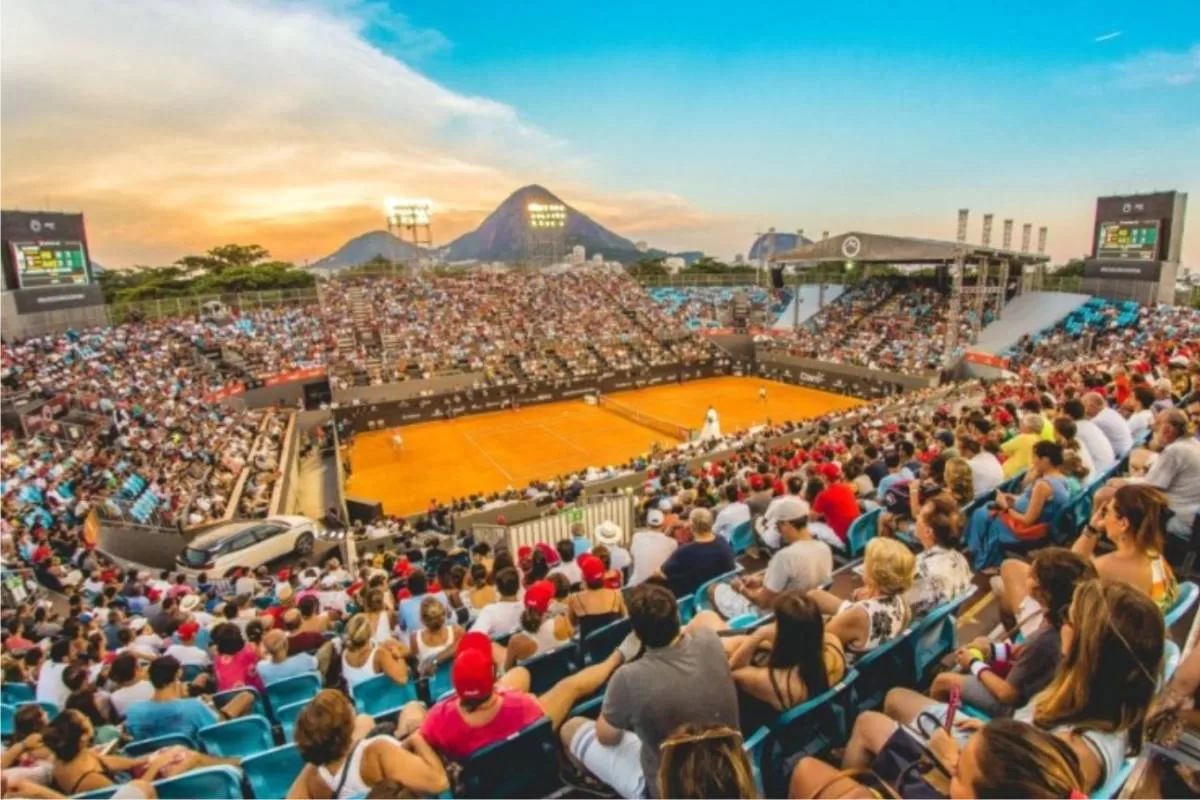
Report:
0,0,1200,265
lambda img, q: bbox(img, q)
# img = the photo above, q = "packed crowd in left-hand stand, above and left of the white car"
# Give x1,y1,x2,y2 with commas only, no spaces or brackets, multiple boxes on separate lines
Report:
0,324,295,531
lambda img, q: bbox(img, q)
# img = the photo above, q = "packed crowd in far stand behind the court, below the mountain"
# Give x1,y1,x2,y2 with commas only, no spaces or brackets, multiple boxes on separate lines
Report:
178,269,712,386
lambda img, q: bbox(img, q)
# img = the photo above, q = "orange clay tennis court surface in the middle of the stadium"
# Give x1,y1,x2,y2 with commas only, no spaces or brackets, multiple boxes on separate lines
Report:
346,378,862,515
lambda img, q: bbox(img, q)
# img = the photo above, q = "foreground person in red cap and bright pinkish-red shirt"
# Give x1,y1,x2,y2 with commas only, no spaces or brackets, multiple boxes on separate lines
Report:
421,632,636,769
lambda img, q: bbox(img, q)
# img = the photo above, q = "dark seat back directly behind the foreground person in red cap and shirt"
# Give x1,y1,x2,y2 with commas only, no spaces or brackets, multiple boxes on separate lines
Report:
461,717,562,798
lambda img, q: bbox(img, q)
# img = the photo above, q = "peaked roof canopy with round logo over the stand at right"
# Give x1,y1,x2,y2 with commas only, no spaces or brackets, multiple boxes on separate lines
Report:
772,230,1050,267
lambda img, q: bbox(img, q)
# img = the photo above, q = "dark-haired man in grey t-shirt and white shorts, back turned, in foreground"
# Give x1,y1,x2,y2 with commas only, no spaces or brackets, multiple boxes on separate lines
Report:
560,584,738,798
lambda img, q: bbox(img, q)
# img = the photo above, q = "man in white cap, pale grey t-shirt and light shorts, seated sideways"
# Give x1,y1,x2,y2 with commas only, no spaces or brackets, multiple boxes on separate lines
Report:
710,494,833,619
